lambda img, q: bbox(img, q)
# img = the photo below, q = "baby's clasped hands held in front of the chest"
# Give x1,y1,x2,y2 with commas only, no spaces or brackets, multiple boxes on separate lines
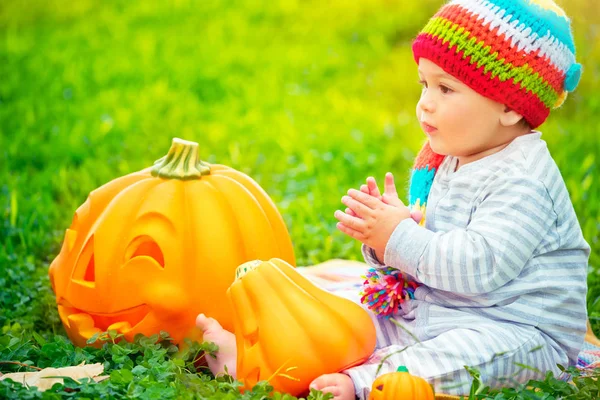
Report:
334,172,411,255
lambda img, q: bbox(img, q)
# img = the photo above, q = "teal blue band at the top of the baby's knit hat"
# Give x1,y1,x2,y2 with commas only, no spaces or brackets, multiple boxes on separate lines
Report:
480,0,575,54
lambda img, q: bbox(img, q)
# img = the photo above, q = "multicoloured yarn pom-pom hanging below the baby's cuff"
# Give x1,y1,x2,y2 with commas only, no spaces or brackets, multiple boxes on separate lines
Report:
360,267,417,318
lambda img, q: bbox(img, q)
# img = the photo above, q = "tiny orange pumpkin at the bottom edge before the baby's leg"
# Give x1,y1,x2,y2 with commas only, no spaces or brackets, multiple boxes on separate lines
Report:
369,366,434,400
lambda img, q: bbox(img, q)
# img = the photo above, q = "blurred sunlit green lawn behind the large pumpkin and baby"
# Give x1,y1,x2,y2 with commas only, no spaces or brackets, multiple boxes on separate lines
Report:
0,0,600,398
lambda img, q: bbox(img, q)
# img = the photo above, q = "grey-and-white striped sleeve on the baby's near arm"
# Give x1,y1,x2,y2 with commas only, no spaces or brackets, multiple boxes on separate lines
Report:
384,177,557,294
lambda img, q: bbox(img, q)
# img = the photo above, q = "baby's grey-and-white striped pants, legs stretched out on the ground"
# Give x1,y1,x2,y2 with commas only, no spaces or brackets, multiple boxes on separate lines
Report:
337,291,568,399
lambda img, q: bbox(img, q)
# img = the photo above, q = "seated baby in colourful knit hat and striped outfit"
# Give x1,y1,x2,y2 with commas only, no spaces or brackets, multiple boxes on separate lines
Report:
197,0,590,400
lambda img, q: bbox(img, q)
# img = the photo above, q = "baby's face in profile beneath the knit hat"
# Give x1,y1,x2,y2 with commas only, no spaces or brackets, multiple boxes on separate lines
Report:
417,58,506,157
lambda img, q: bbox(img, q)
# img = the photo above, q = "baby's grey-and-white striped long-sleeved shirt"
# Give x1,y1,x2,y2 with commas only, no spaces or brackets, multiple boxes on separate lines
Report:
363,131,590,365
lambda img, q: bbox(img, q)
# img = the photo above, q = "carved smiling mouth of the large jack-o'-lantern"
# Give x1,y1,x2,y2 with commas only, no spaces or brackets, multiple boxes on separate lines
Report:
58,299,151,337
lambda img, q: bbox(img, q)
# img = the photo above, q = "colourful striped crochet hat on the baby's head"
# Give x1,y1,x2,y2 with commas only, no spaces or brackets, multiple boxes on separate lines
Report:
412,0,581,128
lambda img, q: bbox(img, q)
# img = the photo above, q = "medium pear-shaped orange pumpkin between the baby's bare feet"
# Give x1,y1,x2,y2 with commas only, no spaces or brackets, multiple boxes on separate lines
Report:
227,259,376,396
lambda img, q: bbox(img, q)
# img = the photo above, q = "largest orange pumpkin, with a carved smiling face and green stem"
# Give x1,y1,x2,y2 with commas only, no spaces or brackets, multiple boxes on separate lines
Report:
49,138,295,346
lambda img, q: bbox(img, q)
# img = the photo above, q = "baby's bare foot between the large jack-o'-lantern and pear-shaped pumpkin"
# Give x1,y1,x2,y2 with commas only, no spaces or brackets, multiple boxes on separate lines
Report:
196,314,237,378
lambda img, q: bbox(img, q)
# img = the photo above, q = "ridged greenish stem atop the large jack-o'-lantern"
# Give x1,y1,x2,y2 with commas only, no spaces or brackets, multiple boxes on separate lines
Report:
151,138,210,180
